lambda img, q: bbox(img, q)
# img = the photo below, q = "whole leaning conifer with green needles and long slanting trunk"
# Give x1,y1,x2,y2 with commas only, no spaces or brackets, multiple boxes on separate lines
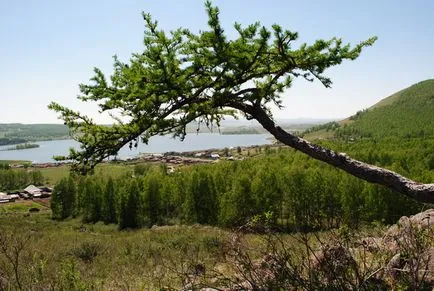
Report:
49,2,434,203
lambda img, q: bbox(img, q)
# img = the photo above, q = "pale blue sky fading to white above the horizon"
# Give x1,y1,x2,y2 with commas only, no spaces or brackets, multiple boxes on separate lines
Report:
0,0,434,123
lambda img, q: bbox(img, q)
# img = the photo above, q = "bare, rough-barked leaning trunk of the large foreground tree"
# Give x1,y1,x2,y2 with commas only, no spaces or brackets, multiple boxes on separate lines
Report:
248,106,434,203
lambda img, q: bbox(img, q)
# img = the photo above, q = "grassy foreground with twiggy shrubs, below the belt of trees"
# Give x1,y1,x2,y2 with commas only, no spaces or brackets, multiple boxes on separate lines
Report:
0,209,434,290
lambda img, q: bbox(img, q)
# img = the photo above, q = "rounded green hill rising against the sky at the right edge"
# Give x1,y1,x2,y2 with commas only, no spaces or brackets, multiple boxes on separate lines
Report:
306,80,434,139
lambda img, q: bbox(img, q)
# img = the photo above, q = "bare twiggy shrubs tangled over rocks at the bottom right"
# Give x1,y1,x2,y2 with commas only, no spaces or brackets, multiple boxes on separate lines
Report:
192,209,434,290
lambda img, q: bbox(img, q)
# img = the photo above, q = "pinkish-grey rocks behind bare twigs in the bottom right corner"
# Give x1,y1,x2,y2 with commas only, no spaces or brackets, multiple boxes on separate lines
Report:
310,209,434,288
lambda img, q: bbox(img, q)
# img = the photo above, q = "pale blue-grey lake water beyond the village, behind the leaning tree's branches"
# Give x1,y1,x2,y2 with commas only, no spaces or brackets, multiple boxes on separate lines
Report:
0,133,272,163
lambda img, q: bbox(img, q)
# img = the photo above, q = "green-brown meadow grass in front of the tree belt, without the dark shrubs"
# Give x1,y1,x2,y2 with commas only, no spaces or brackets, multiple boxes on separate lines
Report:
0,202,431,290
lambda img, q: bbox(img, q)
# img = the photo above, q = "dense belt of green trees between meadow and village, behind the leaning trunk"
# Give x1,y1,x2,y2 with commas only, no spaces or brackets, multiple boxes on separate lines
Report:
51,139,434,232
